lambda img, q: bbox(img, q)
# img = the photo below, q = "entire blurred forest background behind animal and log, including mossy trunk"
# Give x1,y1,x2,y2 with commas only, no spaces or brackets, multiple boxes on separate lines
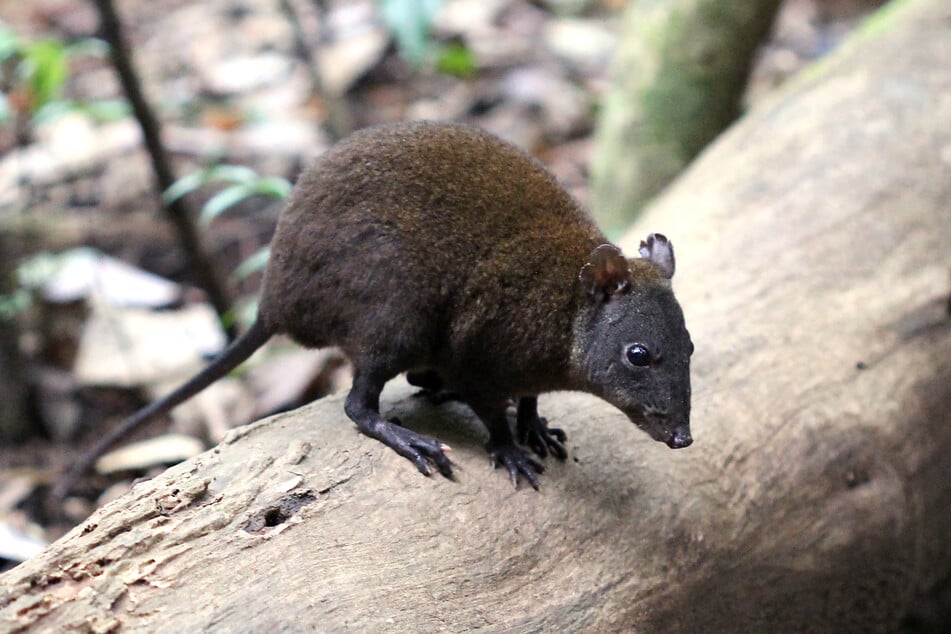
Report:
0,0,883,571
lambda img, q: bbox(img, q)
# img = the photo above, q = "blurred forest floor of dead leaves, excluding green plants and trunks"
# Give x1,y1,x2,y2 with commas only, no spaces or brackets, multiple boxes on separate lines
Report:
0,0,880,571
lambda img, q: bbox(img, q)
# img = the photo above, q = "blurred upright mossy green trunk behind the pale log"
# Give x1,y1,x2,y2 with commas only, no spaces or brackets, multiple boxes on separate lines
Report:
591,0,781,235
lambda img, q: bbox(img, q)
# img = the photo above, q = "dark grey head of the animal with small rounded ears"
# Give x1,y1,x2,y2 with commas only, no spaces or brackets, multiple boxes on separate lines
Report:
573,233,693,449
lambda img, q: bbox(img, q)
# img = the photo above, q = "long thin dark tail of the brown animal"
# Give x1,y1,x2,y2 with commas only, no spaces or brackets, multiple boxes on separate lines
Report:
50,321,271,502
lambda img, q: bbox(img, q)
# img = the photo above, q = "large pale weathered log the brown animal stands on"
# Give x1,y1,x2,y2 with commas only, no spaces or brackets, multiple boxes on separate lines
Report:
0,0,951,632
